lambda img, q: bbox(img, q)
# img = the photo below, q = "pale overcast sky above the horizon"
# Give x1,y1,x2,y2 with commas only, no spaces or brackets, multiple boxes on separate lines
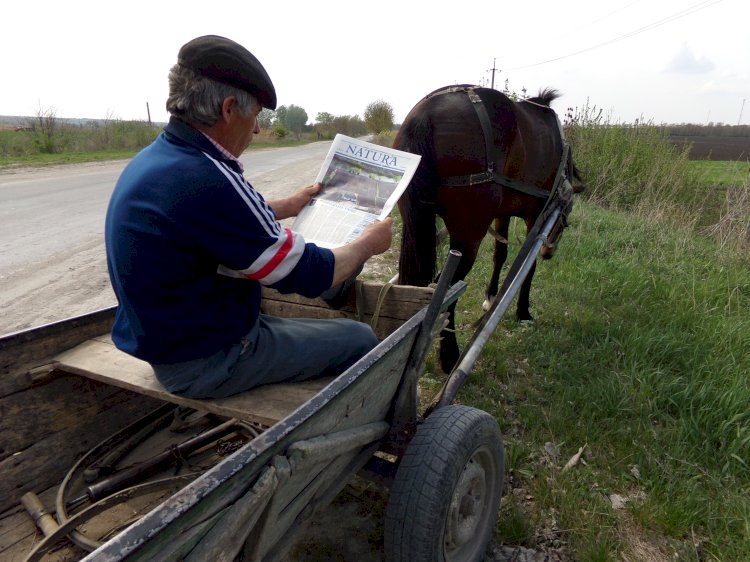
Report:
0,0,750,125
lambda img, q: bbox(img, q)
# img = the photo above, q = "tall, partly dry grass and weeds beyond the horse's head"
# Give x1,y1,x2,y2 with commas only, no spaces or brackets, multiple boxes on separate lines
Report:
565,101,750,249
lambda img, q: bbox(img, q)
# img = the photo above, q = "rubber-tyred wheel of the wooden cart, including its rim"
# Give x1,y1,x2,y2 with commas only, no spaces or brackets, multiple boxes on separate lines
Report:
385,405,504,562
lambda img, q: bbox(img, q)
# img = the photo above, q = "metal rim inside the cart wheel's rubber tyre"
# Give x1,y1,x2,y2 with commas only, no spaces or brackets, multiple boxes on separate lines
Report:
443,447,497,561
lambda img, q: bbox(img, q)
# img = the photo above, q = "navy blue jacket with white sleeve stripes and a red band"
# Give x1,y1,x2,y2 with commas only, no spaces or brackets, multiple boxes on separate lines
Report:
105,118,334,364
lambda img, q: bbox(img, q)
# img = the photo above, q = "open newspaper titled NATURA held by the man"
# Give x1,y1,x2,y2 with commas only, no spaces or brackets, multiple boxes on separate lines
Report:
292,135,421,248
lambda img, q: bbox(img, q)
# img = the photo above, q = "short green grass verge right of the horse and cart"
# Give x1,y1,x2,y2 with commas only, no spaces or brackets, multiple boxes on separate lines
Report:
418,202,750,561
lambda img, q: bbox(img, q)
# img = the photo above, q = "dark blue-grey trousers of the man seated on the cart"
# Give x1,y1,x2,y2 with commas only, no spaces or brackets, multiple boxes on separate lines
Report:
152,314,379,398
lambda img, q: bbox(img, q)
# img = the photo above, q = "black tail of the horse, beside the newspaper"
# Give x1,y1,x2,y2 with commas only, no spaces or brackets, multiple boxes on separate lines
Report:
393,108,437,287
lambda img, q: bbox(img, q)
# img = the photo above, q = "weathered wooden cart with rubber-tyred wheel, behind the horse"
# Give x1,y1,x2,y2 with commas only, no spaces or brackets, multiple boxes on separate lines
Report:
0,255,503,562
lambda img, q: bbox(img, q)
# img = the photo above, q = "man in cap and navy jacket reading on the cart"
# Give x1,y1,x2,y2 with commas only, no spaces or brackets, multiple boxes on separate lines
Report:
105,36,391,398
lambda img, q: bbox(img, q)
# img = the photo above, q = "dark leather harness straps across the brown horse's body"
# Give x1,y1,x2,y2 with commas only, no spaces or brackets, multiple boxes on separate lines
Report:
433,86,569,202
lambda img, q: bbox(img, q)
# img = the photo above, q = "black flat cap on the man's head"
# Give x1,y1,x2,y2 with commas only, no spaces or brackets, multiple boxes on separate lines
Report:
177,35,276,109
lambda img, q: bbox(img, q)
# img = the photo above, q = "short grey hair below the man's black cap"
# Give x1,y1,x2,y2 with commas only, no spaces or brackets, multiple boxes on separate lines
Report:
167,64,258,127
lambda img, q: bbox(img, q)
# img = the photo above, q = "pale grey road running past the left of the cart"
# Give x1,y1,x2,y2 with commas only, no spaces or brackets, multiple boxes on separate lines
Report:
0,142,331,335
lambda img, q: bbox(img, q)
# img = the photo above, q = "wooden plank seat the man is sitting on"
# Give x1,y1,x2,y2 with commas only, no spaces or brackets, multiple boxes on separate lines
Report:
55,334,333,426
